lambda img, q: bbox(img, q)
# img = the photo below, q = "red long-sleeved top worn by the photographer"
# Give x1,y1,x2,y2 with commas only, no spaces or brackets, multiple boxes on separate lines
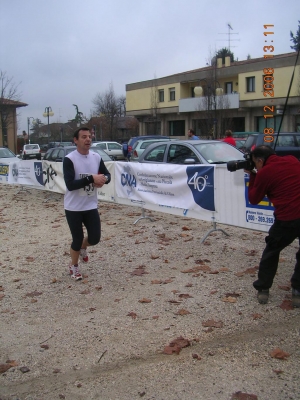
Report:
248,155,300,221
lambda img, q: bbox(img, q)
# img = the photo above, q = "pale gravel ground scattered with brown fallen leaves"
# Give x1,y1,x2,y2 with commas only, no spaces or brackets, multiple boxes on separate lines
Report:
0,185,300,400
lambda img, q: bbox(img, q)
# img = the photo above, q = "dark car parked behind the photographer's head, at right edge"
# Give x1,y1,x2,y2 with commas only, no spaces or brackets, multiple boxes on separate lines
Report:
241,132,300,160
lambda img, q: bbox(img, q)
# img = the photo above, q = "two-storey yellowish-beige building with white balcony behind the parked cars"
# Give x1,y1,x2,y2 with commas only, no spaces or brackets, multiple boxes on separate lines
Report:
126,52,300,139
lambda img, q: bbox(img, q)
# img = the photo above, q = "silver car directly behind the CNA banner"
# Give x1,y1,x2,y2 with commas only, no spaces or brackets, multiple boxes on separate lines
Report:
138,140,244,165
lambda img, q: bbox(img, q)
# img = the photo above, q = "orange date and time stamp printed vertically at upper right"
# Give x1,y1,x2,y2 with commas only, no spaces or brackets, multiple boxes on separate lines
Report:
263,25,274,143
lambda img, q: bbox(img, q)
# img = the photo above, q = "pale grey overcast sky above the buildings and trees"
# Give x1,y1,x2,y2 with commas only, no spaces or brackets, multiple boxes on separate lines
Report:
0,0,300,134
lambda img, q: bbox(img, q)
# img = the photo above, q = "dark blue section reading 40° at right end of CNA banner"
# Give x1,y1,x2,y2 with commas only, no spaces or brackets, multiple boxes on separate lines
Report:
186,166,215,211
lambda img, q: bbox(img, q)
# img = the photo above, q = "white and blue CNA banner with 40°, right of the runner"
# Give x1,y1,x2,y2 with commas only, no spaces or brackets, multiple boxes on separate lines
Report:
115,163,215,212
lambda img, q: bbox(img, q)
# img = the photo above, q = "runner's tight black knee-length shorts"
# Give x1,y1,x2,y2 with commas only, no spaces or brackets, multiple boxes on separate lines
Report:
65,209,101,251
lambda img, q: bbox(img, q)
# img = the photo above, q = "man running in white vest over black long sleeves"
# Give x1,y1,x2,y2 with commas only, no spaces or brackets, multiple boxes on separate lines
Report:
63,127,111,280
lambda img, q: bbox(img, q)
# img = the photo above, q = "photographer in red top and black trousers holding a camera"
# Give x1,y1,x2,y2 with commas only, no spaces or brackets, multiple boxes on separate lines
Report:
245,145,300,307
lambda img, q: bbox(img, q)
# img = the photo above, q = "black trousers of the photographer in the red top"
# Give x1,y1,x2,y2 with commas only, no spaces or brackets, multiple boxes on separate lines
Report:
253,219,300,290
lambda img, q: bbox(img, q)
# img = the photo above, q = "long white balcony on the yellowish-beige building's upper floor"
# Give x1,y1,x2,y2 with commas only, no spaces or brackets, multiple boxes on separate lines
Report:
179,93,240,112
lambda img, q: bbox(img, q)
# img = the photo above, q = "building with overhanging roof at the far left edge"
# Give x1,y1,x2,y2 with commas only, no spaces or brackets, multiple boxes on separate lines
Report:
0,97,28,153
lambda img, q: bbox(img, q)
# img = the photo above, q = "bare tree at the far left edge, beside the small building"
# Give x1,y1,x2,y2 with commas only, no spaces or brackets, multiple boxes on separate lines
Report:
0,70,21,144
